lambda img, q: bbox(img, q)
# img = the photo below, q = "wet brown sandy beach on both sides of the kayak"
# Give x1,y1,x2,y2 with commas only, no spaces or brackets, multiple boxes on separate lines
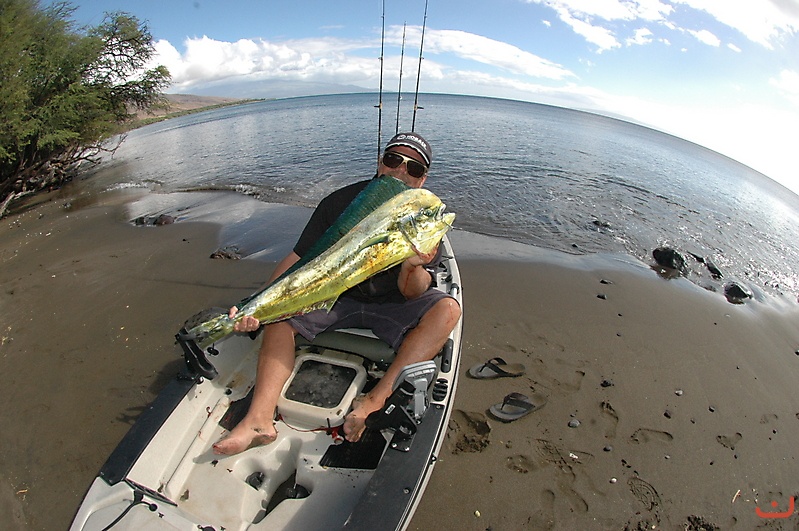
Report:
0,187,799,530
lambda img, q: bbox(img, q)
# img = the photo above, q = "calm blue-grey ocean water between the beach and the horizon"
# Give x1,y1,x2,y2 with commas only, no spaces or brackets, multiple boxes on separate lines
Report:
86,94,799,303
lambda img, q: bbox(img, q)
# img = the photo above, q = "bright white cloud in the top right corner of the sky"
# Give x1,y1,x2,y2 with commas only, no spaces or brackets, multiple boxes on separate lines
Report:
674,0,799,49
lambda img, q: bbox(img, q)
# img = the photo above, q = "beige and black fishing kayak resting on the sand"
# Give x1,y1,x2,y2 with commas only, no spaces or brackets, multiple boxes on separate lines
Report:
70,237,463,531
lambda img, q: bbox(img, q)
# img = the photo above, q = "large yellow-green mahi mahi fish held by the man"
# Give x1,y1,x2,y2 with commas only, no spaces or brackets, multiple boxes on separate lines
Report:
186,176,455,346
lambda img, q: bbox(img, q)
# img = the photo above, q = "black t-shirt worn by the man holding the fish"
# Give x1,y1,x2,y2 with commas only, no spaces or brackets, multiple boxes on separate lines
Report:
294,179,441,303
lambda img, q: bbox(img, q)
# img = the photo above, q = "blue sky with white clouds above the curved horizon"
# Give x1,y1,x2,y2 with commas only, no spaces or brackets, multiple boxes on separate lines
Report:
70,0,799,194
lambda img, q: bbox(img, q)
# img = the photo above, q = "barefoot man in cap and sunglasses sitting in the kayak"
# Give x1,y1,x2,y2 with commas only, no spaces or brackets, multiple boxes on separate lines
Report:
214,133,461,455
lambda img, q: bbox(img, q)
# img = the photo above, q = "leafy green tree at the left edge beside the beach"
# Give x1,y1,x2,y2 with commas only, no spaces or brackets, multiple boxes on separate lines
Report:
0,0,170,216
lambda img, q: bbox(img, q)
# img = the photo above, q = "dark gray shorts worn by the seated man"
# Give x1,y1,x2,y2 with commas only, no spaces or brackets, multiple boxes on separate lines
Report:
289,288,449,351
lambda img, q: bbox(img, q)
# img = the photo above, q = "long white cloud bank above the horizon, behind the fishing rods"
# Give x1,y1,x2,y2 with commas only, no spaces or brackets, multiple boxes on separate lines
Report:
154,26,575,90
